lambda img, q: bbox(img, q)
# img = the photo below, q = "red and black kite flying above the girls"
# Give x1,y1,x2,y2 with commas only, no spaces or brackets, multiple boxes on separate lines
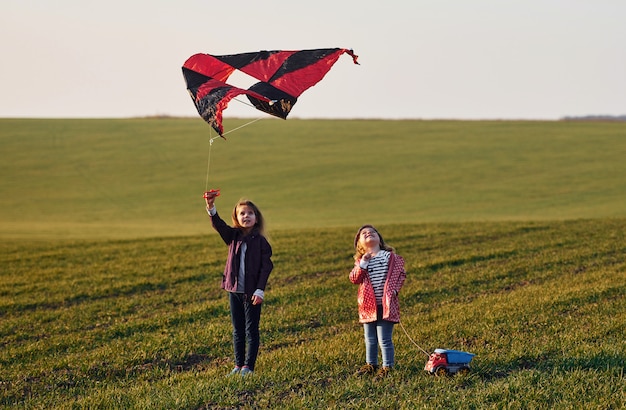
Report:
182,48,359,138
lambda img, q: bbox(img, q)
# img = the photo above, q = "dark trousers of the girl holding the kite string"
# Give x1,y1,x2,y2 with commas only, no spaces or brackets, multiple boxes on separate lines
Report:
228,293,262,370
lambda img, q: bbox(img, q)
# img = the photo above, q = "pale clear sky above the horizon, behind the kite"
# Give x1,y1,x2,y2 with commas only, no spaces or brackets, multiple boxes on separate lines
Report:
0,0,626,120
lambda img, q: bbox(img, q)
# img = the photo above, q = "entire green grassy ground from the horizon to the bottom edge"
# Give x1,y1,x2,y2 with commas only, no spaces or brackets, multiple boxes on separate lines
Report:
0,119,626,409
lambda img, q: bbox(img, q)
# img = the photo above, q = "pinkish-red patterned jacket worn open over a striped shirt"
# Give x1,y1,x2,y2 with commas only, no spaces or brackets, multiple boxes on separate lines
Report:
350,252,406,323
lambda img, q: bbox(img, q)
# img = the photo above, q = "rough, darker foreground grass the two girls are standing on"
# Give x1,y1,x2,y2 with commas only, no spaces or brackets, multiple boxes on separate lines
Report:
0,219,626,409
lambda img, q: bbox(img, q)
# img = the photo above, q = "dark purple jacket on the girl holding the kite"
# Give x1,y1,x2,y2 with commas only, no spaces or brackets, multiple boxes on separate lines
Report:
211,213,274,296
